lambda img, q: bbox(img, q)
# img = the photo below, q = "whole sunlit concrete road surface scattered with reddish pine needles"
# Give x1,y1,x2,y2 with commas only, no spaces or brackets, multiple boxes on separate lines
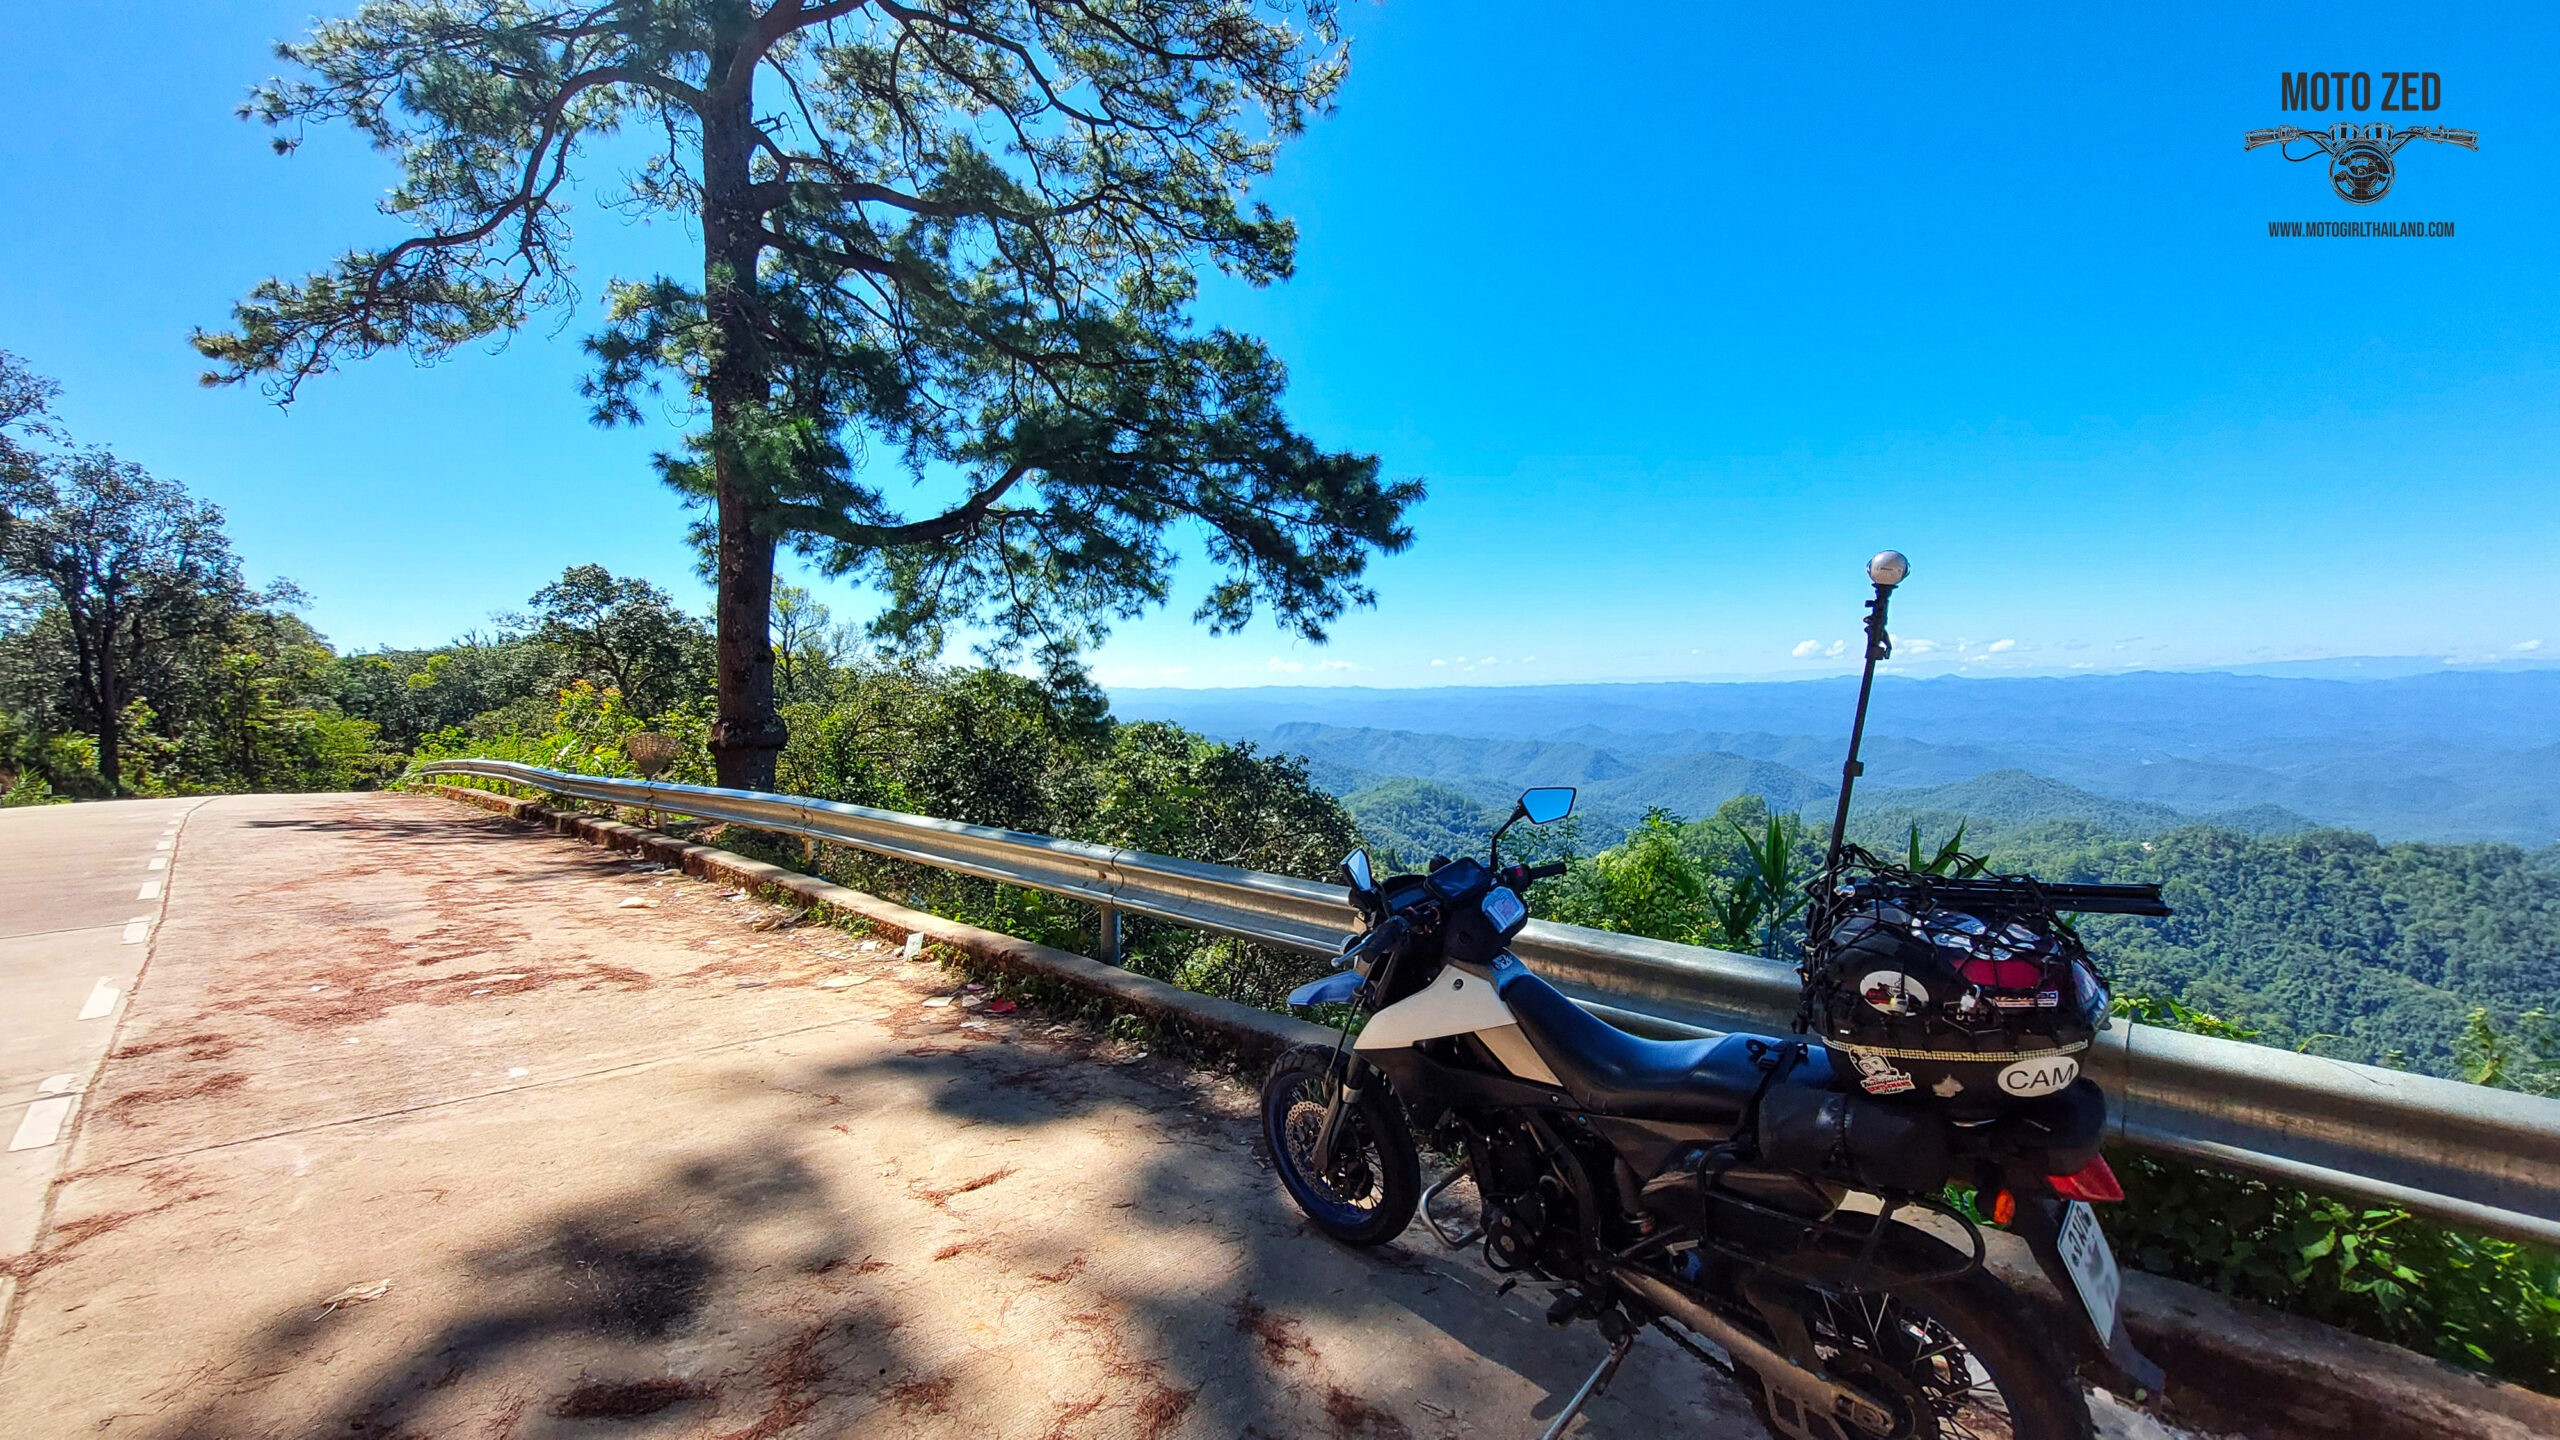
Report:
0,794,2181,1440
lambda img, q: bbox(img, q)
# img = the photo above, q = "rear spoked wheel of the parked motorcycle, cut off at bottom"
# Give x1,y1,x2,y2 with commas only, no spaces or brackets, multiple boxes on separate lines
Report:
1743,1271,2092,1440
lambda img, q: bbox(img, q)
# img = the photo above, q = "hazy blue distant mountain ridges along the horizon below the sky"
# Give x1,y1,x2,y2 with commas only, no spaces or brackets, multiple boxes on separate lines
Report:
1114,669,2560,846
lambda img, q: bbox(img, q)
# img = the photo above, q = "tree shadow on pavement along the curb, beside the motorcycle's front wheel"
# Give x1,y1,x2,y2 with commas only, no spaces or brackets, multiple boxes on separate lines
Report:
814,1024,1759,1440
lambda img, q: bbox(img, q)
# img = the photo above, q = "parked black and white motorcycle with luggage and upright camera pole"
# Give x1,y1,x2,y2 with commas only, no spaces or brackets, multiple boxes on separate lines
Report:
1262,553,2166,1440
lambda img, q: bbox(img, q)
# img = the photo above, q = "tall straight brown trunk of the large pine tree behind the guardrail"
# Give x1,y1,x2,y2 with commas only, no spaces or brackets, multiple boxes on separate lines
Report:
701,25,786,789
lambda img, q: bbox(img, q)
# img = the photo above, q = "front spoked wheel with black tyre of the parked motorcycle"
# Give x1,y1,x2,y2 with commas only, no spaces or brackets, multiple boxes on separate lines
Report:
1262,1045,1423,1245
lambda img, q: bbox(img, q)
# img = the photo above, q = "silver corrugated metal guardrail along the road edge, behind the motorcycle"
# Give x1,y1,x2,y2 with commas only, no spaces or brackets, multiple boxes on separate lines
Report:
415,761,2560,1245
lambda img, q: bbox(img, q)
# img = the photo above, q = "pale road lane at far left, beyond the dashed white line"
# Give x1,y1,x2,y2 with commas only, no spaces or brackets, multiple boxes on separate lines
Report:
0,799,197,1297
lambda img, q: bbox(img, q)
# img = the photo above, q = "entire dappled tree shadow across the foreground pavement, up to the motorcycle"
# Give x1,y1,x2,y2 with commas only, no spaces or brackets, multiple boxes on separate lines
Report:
129,968,1756,1440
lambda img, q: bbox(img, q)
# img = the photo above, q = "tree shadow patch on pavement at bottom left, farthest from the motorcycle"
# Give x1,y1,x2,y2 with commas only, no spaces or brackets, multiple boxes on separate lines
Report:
135,1140,926,1440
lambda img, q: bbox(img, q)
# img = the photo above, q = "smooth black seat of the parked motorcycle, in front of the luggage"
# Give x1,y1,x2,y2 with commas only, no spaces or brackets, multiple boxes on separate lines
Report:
1495,956,1761,1125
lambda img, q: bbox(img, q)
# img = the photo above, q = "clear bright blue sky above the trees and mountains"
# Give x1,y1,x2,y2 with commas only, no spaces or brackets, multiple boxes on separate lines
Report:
0,0,2560,684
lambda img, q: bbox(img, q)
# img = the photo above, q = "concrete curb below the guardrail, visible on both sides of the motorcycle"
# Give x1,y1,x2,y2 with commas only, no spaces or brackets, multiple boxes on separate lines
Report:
417,784,2560,1440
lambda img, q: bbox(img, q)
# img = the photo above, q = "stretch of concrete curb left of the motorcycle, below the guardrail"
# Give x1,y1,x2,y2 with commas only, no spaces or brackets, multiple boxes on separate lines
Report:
422,784,1334,1068
